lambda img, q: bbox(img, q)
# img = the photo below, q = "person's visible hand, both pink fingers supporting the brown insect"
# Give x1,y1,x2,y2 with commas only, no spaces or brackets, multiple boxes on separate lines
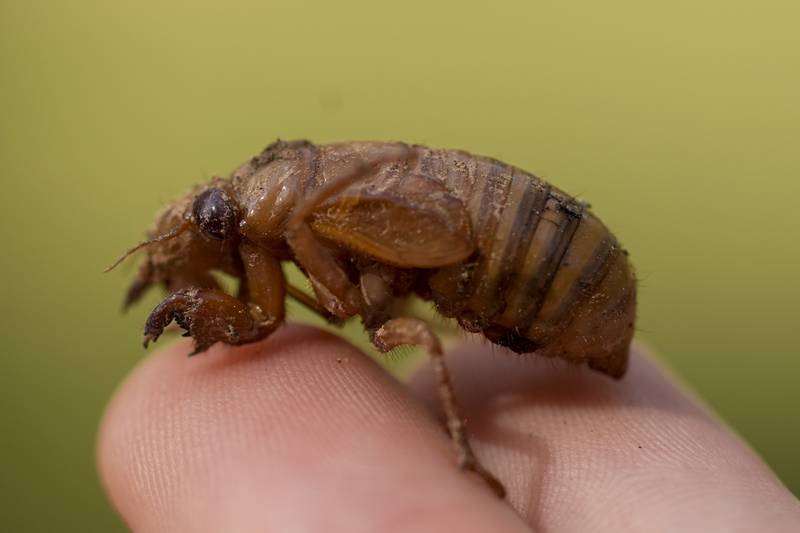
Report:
98,326,800,533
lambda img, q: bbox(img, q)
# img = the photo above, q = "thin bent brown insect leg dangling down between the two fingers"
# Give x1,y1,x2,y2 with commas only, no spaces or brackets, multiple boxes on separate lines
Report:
371,318,506,498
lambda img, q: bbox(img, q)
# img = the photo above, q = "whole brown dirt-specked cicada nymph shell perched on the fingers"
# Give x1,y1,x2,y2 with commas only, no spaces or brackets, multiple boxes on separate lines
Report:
111,141,636,496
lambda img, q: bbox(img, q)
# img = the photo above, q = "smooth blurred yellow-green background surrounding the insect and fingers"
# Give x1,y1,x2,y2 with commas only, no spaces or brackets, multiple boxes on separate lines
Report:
0,0,800,531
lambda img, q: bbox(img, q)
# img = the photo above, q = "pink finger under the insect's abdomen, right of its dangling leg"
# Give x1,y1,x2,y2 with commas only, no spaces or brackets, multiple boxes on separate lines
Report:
414,344,800,533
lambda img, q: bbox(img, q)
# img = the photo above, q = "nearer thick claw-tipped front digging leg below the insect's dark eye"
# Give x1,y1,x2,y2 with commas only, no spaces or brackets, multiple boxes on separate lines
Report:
144,243,286,355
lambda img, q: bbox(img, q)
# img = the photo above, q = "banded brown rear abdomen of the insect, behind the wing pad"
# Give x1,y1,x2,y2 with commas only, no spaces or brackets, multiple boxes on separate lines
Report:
420,151,635,376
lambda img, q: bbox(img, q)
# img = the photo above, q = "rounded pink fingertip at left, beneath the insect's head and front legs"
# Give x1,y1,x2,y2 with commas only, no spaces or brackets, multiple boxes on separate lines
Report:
98,326,524,532
